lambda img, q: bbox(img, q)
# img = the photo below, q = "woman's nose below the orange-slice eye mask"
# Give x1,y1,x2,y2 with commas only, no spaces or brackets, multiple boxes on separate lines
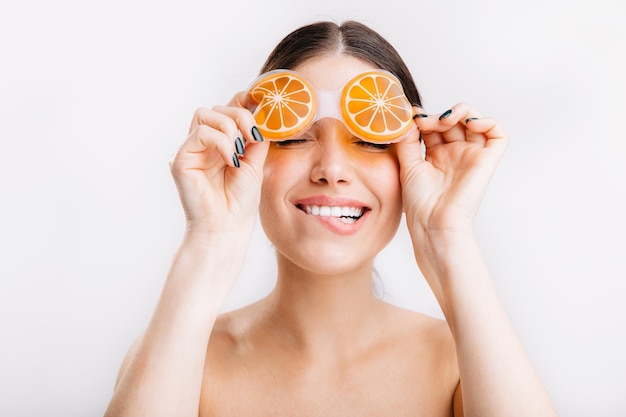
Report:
311,120,354,185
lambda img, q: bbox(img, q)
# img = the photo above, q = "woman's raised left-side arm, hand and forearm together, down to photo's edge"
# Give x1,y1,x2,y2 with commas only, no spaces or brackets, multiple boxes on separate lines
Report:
105,94,267,417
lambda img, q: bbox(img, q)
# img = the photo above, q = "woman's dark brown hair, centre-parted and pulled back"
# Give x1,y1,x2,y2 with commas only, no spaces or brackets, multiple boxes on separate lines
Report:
261,20,422,107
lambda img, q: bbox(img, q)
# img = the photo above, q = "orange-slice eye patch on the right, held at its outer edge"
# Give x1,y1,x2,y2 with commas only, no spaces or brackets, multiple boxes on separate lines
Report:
341,71,415,143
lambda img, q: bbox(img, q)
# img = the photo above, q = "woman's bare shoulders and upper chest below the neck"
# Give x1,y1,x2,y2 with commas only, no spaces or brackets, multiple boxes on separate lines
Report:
200,302,458,417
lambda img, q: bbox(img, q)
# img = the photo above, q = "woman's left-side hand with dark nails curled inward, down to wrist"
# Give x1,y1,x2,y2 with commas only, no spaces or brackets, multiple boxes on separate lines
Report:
170,92,269,238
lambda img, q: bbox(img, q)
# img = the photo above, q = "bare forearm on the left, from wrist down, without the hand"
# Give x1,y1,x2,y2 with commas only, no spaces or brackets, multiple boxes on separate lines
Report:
106,234,240,416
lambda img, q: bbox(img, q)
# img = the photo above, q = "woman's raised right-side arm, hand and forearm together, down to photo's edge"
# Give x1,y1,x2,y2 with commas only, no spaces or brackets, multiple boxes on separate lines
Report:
398,104,556,417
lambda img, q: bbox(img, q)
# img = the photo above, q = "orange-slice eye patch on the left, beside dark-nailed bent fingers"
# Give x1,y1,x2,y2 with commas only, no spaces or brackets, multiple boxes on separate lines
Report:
248,70,316,140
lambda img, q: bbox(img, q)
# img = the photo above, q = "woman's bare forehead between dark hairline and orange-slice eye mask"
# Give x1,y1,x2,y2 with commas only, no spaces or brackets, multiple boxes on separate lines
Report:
293,54,376,91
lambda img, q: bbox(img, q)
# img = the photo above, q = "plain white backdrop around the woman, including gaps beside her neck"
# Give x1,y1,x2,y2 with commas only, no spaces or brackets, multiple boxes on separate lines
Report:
0,0,626,417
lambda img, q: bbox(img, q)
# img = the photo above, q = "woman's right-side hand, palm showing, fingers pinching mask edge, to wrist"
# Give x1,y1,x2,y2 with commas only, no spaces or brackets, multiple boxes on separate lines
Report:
397,103,508,235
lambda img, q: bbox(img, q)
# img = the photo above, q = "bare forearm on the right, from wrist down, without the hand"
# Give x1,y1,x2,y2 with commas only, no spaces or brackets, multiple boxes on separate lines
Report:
420,229,556,416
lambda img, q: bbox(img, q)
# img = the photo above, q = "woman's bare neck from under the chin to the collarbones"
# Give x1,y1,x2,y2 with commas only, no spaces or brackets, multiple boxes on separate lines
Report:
260,255,383,357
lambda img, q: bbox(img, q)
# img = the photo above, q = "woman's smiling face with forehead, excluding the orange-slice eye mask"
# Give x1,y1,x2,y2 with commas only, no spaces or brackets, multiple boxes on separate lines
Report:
260,55,402,274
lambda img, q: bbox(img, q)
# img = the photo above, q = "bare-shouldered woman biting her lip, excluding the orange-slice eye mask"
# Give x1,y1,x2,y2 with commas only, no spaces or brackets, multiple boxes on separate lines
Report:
106,22,556,417
